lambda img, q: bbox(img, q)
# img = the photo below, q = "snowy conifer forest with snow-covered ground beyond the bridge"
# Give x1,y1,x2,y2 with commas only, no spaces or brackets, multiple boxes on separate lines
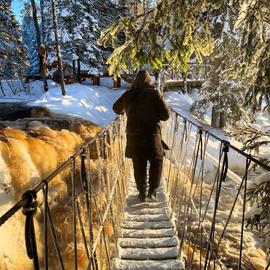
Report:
0,0,270,269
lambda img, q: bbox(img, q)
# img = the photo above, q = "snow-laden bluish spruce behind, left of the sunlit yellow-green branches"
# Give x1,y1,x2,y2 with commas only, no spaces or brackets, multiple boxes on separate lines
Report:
45,0,122,72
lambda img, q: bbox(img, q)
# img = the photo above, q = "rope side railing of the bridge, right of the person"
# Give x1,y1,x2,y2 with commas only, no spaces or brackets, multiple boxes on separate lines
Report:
163,110,270,270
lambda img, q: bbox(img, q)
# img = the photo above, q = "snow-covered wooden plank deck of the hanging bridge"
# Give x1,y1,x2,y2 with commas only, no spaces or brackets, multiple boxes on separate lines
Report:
114,177,184,270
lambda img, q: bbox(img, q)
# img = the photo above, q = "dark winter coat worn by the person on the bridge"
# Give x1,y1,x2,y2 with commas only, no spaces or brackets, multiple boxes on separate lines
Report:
113,87,169,159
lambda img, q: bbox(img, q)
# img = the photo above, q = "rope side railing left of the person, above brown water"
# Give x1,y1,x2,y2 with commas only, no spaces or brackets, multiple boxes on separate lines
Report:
0,117,130,270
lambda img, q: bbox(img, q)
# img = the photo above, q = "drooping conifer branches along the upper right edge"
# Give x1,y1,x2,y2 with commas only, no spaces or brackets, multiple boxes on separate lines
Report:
234,0,270,112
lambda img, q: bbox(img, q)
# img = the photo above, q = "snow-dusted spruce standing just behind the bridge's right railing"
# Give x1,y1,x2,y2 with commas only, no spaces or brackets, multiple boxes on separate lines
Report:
192,2,252,128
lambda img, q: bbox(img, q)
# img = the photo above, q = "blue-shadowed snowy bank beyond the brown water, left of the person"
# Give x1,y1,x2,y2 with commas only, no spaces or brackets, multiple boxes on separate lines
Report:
0,78,129,127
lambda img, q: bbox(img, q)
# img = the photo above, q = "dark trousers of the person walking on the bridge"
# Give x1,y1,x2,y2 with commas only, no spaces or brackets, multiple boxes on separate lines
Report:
132,158,163,194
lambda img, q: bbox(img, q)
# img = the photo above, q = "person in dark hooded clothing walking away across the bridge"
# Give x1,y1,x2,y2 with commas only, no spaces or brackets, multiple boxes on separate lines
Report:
113,70,170,202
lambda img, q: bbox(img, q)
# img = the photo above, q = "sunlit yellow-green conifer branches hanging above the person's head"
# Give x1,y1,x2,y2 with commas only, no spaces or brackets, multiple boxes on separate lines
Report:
99,0,215,76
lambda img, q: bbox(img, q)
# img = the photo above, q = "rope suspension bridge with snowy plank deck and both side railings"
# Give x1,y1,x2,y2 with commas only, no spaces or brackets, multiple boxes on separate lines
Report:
0,108,270,270
